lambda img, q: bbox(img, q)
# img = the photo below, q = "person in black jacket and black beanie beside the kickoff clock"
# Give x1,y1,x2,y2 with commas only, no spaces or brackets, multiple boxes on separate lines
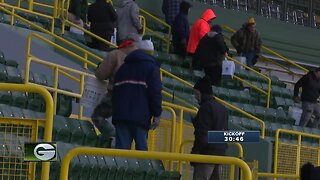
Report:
191,76,228,180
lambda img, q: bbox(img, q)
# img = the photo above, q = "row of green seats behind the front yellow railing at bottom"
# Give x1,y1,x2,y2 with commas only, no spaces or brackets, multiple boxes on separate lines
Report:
36,142,180,180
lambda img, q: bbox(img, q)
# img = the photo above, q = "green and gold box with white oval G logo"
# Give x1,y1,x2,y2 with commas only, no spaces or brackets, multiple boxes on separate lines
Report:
24,142,57,162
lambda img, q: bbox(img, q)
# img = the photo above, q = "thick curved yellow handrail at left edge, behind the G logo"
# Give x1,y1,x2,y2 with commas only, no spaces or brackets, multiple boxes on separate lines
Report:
0,83,53,180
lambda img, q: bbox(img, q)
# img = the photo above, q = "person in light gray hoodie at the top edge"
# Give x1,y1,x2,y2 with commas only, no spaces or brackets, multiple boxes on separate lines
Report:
117,0,142,42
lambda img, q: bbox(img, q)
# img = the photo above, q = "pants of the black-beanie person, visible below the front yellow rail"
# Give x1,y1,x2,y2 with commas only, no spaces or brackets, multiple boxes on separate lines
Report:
193,163,221,180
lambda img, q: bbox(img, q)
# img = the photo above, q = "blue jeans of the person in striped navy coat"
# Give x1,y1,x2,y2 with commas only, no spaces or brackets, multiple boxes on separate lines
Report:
115,123,149,151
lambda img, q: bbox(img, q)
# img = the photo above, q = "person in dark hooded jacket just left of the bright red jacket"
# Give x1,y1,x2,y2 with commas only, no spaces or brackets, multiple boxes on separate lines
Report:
172,1,191,59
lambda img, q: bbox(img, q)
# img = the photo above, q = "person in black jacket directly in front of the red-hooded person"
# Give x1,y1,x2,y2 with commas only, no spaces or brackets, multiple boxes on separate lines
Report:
192,24,229,85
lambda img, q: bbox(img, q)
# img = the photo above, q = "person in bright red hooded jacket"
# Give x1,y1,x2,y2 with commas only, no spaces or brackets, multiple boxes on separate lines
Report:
187,9,216,56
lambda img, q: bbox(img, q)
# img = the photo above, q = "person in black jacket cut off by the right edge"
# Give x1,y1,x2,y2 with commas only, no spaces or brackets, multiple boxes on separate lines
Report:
293,68,320,128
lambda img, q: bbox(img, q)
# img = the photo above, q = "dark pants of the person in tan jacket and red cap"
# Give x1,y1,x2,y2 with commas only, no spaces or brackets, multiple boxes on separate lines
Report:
91,94,115,137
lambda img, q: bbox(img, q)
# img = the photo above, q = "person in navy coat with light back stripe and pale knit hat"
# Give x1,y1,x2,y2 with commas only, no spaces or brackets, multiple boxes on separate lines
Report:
112,40,162,151
